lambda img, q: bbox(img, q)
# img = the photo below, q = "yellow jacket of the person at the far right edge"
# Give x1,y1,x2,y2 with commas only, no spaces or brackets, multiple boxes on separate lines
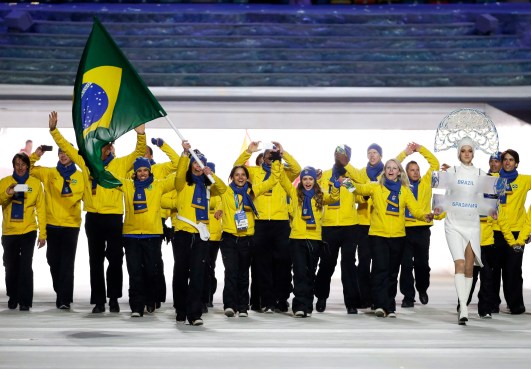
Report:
494,174,531,232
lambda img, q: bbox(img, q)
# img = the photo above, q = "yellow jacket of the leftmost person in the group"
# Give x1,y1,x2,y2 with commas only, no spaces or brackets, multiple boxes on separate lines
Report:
0,172,46,239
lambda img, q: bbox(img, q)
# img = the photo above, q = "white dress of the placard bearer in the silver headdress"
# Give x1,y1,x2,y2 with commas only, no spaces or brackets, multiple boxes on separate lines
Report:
444,165,486,267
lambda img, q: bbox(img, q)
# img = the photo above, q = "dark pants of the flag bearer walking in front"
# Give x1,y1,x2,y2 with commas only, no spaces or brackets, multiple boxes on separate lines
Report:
172,231,209,323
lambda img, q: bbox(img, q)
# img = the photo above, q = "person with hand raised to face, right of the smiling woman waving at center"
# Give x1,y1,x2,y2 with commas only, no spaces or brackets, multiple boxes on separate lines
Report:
315,145,365,314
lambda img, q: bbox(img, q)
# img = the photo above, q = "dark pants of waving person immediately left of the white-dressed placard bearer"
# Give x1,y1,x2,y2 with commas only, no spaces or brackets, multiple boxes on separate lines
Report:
400,226,431,302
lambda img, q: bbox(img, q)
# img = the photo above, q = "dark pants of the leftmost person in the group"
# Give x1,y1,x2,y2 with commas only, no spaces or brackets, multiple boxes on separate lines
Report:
2,231,37,307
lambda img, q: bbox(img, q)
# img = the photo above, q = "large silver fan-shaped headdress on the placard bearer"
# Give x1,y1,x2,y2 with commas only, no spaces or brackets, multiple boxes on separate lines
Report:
435,108,499,155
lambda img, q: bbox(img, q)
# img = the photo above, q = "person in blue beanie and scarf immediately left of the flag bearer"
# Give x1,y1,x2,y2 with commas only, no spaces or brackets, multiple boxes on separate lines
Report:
118,157,175,317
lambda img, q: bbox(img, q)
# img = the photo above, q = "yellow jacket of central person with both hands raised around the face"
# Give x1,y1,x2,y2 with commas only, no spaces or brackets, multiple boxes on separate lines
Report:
234,151,301,220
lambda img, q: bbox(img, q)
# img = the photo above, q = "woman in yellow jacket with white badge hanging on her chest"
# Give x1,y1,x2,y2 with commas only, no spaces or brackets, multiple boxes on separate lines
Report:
220,160,281,317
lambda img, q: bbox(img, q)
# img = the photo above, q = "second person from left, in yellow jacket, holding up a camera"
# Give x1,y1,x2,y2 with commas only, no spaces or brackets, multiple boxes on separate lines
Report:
30,139,85,309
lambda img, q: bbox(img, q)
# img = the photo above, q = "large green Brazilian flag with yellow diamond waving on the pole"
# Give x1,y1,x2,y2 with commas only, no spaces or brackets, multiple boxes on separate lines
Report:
72,19,166,188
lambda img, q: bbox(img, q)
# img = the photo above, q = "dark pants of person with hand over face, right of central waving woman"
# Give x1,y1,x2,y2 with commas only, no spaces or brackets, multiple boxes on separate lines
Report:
315,226,360,308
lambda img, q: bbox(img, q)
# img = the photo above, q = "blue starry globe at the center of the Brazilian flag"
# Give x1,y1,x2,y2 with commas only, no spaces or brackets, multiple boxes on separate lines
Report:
81,82,109,130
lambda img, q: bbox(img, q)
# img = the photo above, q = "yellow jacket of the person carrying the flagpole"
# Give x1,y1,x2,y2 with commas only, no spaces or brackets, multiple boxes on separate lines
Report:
175,156,227,233
